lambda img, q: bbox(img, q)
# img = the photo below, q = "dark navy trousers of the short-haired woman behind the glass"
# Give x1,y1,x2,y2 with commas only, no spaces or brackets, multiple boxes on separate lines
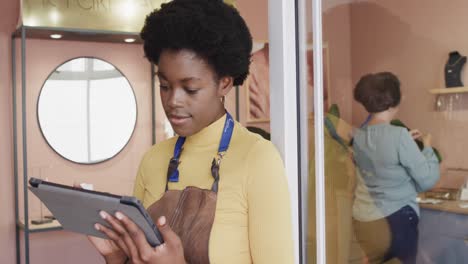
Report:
354,205,419,264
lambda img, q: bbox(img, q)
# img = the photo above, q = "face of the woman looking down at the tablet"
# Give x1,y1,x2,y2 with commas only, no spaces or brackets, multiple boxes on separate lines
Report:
157,50,233,137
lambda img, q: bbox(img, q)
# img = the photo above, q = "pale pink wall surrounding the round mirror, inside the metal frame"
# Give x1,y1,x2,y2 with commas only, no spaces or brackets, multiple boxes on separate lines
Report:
12,40,151,263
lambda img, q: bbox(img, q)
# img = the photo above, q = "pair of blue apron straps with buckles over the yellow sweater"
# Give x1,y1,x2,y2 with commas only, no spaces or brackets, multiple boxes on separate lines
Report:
166,112,234,193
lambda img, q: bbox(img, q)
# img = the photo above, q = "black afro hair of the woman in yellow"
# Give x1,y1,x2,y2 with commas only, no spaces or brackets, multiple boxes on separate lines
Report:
140,0,252,85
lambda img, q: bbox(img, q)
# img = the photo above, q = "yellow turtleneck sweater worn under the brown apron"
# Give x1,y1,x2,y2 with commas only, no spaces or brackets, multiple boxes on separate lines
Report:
134,115,294,264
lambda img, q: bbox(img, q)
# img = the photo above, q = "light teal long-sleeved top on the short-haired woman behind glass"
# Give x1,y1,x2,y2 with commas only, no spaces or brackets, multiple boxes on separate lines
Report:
353,123,440,221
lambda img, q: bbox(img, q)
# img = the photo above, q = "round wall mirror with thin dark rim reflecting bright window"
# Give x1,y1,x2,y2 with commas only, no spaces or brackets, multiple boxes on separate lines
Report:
37,57,137,164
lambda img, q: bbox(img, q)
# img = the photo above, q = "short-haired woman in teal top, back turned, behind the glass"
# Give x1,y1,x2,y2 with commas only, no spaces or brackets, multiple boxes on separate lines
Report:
353,72,440,263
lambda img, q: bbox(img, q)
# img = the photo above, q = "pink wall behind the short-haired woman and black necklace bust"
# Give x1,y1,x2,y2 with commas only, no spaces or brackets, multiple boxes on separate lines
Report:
351,0,468,169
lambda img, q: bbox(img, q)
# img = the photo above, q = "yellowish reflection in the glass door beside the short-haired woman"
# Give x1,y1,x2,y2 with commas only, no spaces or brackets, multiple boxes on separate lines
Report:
306,109,360,263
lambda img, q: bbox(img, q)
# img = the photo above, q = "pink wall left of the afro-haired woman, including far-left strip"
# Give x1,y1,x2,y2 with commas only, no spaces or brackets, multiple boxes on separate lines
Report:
0,0,151,263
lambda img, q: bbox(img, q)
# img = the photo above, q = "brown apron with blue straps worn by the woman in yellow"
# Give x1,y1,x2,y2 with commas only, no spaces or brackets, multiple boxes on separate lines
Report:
148,113,234,264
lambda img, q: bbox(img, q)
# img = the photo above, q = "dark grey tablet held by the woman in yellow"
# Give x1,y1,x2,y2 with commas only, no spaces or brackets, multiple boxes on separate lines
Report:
28,178,163,247
